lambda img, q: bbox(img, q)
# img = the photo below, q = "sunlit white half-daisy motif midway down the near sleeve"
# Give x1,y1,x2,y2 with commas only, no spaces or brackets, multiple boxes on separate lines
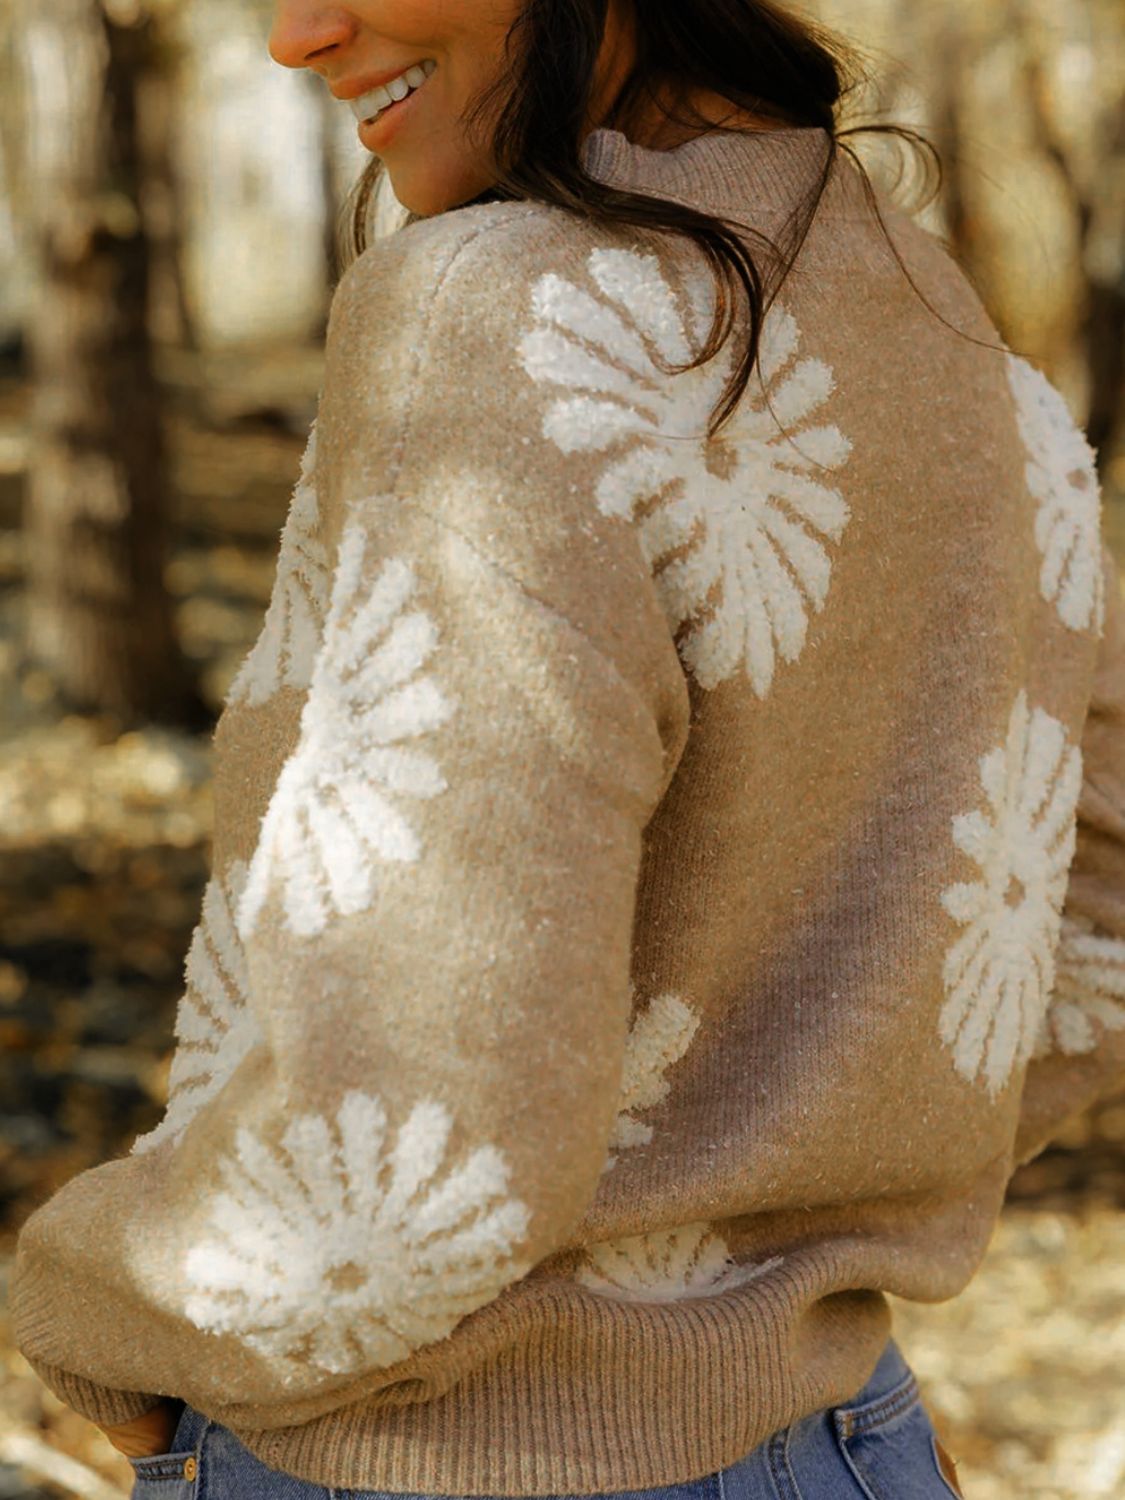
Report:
237,522,456,942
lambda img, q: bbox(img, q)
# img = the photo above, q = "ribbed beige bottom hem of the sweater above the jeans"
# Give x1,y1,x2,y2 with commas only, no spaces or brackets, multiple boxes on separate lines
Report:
230,1277,891,1496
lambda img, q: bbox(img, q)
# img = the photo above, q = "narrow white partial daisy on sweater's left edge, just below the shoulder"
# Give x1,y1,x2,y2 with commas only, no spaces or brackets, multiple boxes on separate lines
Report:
227,422,330,708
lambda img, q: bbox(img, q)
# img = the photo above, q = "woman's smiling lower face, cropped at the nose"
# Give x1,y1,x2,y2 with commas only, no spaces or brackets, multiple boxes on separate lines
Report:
270,0,627,216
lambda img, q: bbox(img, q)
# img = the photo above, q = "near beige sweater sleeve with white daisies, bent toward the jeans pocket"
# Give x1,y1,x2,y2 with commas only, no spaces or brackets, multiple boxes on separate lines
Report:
12,207,690,1428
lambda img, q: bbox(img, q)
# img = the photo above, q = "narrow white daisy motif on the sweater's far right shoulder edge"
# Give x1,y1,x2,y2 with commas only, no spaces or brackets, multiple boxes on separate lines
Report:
1007,354,1106,636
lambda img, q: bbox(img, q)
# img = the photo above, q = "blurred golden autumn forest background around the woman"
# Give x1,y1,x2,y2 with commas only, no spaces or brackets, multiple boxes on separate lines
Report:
0,0,1125,1500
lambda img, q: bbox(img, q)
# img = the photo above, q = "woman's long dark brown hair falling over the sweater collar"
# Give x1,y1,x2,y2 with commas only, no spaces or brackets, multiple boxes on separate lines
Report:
345,0,980,437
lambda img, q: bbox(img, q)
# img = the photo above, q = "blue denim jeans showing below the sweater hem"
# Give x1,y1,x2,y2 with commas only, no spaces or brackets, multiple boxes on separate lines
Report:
129,1340,960,1500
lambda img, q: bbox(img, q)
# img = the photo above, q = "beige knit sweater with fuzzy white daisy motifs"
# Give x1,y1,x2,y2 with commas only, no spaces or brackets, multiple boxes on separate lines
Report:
12,129,1125,1496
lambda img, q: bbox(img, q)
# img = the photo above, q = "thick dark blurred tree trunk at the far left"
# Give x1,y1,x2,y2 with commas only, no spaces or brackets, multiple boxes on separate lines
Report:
24,0,210,728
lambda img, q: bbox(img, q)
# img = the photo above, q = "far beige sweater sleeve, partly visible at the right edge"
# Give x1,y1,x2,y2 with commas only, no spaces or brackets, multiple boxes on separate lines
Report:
1014,542,1125,1166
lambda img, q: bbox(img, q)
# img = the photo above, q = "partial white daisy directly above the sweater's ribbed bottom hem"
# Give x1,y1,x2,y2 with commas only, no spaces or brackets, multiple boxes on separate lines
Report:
575,1223,785,1302
